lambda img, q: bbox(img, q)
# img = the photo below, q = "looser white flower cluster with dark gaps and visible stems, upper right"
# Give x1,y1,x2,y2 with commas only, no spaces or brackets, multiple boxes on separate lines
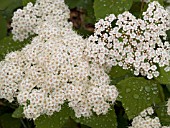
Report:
88,1,170,79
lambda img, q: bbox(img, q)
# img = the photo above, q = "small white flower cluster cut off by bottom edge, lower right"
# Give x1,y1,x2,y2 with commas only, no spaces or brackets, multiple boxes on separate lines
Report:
129,107,170,128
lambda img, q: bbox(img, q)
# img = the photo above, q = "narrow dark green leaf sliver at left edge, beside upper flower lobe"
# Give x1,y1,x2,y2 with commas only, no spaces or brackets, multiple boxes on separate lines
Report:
0,13,7,40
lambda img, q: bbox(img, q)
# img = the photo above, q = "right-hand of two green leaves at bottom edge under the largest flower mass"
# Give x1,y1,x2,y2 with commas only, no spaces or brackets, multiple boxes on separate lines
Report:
71,108,117,128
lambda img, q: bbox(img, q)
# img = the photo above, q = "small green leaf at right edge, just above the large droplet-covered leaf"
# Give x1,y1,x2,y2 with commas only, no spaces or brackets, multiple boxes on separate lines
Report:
155,67,170,84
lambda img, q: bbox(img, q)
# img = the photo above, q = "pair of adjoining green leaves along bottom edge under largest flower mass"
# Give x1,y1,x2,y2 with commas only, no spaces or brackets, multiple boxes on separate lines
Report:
35,104,117,128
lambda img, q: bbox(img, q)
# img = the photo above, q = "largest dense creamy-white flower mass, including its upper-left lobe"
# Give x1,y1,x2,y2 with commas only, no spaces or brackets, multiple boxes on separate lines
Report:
0,0,118,119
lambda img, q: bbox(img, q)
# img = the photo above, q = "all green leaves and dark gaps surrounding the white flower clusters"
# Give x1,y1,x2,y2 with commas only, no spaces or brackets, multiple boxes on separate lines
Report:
0,0,170,128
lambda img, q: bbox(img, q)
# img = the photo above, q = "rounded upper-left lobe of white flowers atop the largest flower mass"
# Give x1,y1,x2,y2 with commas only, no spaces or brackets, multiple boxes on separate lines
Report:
11,0,70,41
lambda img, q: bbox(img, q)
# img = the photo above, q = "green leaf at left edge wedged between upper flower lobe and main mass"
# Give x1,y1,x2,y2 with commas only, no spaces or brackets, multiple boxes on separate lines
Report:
0,36,30,61
